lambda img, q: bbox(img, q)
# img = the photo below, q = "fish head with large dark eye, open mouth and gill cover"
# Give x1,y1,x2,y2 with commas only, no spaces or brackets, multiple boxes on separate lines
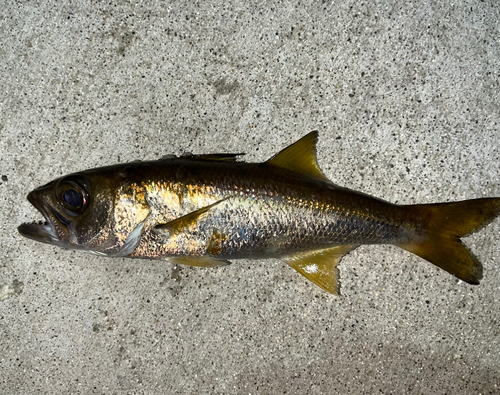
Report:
18,170,149,256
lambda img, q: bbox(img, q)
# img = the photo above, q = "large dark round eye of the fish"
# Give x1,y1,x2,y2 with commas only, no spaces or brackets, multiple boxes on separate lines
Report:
56,175,89,216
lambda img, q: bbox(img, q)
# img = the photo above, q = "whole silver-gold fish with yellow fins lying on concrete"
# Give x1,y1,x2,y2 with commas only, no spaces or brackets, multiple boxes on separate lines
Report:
18,131,500,294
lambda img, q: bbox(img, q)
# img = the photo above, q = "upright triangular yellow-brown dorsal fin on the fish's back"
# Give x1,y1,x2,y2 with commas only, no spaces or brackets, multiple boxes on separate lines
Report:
266,130,330,181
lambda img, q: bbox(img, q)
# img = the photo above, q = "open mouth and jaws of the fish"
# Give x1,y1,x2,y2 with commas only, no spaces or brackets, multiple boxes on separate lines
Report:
17,188,69,244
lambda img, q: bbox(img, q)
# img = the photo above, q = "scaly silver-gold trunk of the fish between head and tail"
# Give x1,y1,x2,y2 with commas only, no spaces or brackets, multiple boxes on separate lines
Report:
128,158,411,259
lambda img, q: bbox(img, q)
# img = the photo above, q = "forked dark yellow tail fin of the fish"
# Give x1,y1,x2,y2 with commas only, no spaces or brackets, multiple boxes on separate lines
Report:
398,198,500,284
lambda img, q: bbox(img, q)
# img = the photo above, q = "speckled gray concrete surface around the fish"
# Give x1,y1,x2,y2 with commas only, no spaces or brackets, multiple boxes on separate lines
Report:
0,0,500,394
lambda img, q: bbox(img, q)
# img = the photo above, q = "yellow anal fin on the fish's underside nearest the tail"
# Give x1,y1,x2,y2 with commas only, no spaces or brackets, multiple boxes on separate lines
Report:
283,245,357,295
